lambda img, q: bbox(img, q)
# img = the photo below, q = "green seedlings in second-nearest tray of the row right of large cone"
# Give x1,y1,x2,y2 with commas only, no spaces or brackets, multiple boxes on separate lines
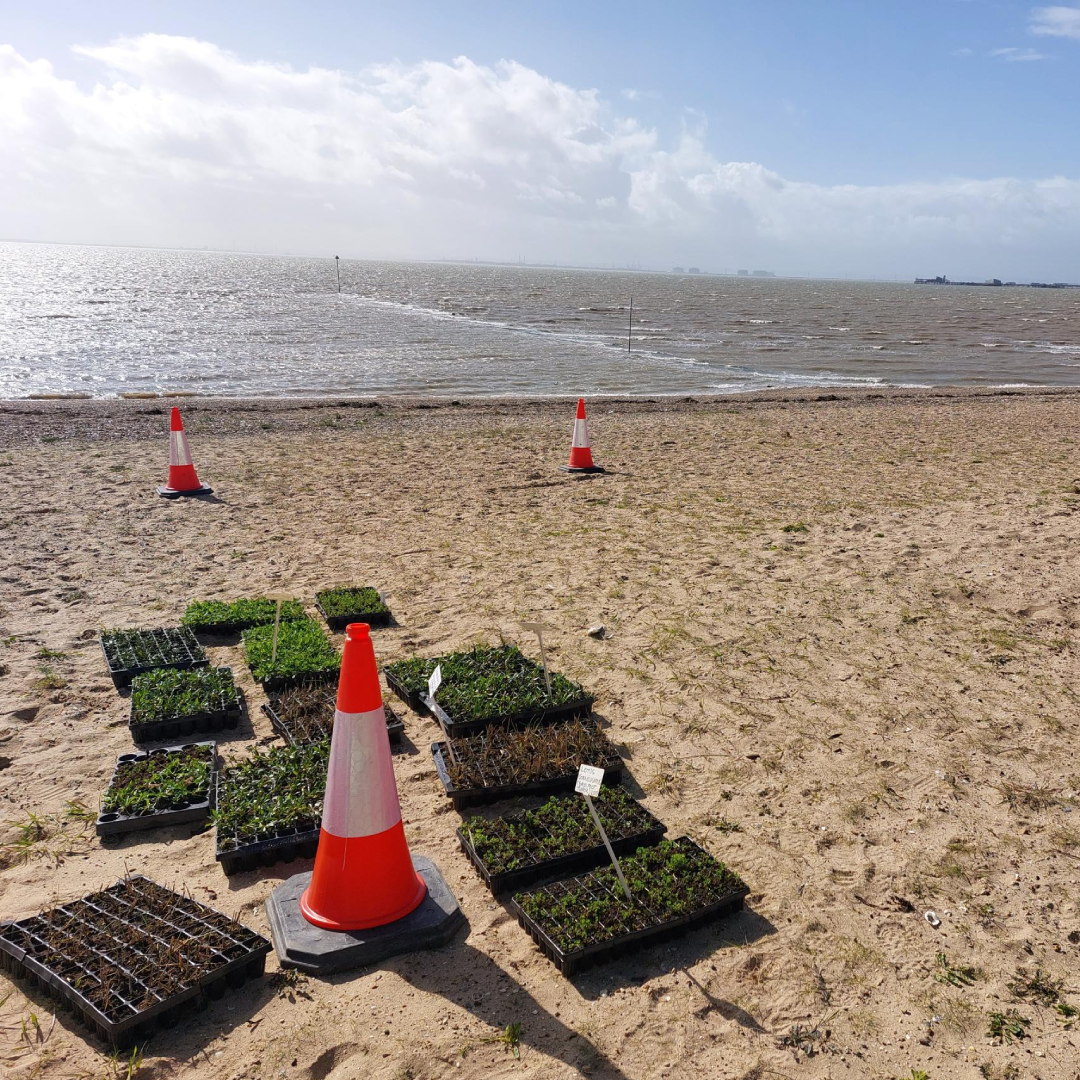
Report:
461,787,659,874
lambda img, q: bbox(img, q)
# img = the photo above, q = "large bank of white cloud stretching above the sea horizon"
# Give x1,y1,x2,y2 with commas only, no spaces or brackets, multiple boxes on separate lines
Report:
0,35,1080,276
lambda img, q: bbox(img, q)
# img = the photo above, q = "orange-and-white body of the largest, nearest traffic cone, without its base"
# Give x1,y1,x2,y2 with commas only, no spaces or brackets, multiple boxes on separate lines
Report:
300,622,427,930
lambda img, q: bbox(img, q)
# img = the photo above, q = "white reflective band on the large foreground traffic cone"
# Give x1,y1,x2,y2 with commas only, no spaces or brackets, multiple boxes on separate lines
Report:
323,705,402,838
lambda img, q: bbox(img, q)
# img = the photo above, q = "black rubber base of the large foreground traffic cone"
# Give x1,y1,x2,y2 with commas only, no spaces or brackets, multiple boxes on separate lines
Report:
267,855,465,975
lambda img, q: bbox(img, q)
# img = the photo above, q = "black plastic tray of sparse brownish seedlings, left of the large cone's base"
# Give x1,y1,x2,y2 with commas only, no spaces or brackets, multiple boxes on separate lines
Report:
0,876,271,1049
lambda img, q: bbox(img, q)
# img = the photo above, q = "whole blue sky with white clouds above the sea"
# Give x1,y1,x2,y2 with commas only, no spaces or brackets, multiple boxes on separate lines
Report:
0,0,1080,281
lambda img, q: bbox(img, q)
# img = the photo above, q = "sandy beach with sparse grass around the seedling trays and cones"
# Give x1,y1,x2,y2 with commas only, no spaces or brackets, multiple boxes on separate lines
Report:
0,390,1080,1080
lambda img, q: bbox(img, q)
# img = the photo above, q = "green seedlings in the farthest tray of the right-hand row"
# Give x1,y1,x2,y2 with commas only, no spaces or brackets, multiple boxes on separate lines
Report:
384,645,591,724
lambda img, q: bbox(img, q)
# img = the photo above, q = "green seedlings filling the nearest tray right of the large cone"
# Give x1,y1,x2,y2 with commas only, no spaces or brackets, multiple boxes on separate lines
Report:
514,837,745,953
